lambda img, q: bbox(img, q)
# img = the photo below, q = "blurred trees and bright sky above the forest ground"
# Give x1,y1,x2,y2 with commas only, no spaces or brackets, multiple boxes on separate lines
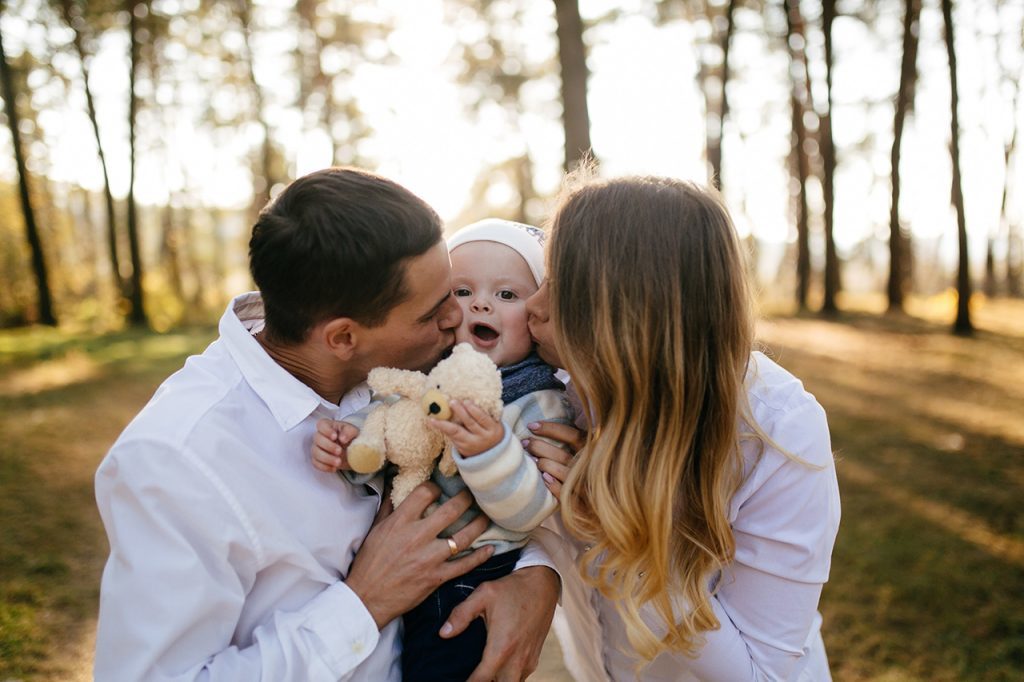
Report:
0,0,1024,333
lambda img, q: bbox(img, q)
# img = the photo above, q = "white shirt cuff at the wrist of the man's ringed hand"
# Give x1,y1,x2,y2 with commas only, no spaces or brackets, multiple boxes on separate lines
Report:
303,581,380,677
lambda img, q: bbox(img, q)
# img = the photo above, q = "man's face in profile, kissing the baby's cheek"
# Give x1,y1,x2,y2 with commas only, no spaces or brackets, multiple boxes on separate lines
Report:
360,242,462,372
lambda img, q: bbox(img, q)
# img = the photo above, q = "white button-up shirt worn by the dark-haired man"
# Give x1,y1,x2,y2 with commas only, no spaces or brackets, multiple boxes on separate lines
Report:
95,293,550,681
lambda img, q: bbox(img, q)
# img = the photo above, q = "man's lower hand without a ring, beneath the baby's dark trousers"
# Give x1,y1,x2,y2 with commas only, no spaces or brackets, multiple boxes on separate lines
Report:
440,566,559,682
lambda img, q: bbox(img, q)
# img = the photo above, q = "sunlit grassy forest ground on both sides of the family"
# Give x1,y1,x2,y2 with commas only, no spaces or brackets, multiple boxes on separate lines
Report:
0,302,1024,681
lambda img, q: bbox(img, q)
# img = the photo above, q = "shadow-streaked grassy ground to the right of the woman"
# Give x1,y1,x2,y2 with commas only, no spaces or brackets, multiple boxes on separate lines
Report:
763,314,1024,680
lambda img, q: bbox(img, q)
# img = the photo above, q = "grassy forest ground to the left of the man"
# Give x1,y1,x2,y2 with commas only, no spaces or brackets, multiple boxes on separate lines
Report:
0,321,214,680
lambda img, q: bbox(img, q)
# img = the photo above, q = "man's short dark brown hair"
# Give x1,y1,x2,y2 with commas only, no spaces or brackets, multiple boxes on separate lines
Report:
249,168,441,343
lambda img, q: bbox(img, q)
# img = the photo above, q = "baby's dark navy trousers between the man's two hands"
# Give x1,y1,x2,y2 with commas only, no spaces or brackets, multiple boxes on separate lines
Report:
401,549,521,682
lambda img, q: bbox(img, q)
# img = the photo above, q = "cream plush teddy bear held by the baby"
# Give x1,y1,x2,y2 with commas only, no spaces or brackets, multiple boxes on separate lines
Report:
348,343,503,506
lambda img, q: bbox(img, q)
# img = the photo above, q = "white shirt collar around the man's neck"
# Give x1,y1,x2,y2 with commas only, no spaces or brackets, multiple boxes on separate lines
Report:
219,292,369,431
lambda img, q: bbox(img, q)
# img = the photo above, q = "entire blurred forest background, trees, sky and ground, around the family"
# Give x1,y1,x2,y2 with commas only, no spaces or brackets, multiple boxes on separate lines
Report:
0,0,1024,680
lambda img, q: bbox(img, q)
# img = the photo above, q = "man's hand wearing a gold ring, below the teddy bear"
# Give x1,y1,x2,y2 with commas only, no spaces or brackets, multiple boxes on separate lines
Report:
345,482,494,628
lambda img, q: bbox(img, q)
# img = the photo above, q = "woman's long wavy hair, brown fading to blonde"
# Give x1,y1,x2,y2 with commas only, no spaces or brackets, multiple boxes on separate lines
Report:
548,177,760,662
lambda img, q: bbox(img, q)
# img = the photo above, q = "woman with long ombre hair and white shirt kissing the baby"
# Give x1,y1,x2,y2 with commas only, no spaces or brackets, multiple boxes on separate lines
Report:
528,178,840,681
